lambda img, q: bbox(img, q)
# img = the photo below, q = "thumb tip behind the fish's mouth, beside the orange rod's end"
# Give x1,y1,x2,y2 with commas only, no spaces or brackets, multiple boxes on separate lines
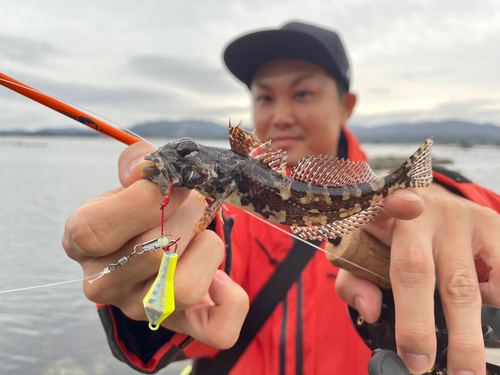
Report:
118,142,157,188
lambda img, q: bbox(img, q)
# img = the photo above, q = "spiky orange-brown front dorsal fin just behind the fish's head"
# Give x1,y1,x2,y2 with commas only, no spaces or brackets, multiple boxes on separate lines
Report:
229,122,286,176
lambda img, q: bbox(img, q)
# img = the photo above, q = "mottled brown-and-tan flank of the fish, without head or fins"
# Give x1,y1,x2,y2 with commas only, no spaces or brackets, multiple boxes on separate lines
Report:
227,153,410,226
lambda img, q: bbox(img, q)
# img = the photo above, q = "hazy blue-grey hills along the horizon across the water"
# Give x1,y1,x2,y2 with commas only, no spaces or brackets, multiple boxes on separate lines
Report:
0,120,500,145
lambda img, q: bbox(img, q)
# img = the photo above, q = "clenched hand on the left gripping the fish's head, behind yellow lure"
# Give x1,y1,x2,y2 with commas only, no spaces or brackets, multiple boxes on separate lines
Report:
63,142,249,349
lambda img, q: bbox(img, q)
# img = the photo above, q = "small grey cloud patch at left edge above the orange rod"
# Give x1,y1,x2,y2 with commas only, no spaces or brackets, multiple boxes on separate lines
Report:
0,35,59,65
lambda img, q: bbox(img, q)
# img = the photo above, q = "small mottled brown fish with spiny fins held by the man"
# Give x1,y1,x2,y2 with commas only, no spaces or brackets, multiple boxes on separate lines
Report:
143,123,433,240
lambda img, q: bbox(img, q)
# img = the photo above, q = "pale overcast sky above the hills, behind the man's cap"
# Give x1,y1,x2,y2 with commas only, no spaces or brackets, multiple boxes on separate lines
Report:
0,0,500,129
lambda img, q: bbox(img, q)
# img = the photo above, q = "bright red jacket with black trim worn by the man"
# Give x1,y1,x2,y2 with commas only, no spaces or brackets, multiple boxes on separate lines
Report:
98,129,500,375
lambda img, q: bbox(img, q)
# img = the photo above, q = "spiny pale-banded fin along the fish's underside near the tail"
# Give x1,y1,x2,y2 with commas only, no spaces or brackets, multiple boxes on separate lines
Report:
291,203,382,241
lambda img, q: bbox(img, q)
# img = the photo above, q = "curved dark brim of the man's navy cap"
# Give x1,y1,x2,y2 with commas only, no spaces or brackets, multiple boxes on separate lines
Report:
224,30,343,88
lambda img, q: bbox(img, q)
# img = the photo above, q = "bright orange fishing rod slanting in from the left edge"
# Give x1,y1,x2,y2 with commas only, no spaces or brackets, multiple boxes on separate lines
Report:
0,73,142,145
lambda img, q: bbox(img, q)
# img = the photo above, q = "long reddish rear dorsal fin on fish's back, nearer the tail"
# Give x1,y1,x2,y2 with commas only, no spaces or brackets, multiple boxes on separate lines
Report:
290,155,377,186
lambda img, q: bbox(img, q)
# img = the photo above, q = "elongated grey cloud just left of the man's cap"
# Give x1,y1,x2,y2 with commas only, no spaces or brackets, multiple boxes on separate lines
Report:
128,55,241,94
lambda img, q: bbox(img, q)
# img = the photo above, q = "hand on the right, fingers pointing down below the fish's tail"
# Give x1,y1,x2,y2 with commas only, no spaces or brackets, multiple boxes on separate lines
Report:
337,184,500,374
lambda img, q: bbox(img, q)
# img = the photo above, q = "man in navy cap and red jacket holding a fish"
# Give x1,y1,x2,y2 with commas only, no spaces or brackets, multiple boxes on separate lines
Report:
63,23,500,374
